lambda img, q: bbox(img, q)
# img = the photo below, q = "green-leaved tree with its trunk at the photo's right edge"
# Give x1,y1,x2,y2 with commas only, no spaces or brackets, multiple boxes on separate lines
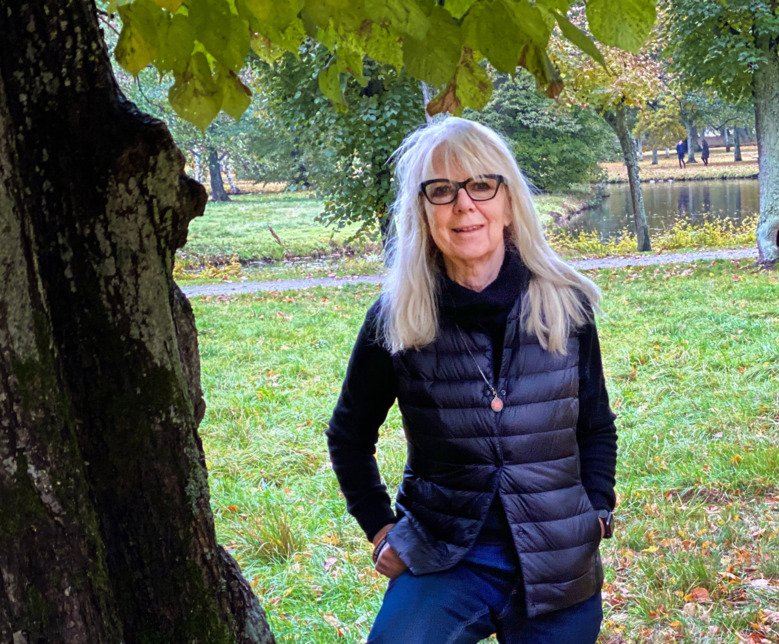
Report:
662,0,779,267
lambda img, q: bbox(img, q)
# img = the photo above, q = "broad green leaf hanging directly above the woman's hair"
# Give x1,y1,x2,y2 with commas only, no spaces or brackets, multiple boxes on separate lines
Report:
403,6,462,85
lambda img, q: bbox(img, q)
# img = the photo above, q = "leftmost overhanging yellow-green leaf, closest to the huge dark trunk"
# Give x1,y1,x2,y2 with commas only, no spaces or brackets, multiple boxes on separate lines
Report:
116,0,164,76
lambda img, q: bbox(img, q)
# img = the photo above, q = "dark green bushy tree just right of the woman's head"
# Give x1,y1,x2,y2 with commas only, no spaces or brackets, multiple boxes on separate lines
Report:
464,71,614,190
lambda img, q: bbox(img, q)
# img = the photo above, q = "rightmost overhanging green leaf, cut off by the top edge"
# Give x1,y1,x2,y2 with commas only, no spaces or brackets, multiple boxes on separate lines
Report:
587,0,657,53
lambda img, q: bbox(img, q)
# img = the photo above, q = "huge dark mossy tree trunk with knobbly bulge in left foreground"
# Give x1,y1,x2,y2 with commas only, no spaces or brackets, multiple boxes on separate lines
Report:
0,0,273,643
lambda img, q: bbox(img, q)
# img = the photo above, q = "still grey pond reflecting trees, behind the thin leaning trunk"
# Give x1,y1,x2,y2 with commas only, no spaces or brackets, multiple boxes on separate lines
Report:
569,179,759,240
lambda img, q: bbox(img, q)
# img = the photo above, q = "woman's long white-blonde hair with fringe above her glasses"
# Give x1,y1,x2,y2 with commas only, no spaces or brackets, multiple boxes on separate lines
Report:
379,117,600,354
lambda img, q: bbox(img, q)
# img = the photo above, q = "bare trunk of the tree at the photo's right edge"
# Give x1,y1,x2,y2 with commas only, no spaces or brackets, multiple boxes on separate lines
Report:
752,39,779,268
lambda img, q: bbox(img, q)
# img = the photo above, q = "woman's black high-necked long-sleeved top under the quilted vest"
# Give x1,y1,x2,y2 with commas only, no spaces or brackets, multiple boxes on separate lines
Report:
327,252,617,540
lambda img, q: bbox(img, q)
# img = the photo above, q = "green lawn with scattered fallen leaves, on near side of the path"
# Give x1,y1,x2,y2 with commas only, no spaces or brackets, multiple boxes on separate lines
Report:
193,262,779,644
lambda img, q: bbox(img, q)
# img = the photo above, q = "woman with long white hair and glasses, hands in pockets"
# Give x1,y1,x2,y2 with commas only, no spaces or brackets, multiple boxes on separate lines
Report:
327,118,616,644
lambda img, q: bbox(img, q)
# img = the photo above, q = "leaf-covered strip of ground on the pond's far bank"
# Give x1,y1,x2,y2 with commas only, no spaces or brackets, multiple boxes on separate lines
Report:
600,145,757,182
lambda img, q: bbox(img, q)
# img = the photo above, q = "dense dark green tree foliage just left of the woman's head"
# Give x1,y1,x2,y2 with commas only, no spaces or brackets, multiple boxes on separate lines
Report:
256,43,425,232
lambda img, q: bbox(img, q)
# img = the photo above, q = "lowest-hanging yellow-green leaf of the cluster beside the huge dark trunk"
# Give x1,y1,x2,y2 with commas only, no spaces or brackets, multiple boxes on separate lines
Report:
168,51,223,132
